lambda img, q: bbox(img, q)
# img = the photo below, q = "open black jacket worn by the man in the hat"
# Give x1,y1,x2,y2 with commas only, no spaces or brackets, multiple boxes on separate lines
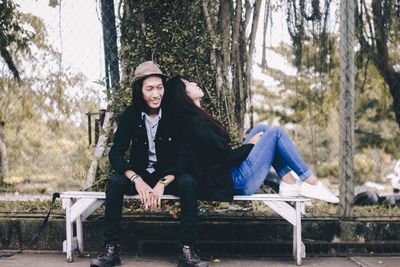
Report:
108,106,177,180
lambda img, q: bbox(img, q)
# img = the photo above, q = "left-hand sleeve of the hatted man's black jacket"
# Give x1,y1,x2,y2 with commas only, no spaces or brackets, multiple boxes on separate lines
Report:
108,110,131,175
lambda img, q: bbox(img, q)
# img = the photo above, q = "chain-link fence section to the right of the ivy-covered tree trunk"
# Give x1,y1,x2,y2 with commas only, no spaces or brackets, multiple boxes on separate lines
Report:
253,1,400,220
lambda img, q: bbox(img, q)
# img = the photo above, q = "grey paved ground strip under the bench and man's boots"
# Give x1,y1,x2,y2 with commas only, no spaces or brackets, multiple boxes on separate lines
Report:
0,252,400,267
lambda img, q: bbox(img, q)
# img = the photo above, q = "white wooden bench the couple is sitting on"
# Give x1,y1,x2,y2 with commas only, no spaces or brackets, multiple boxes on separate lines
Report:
61,191,310,265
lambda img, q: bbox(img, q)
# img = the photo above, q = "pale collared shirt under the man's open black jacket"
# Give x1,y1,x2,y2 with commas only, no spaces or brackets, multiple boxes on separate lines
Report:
142,109,162,173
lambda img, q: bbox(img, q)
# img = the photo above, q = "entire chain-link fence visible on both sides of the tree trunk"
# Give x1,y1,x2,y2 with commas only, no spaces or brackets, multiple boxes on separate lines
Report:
0,0,400,222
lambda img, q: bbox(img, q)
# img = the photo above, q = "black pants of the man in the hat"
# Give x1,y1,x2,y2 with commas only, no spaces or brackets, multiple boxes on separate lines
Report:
104,172,198,244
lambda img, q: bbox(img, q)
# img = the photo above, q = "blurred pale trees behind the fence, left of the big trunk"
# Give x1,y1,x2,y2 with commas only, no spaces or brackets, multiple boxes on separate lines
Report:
0,1,97,193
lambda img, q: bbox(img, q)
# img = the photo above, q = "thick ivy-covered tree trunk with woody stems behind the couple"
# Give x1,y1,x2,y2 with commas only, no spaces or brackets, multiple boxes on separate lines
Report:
121,0,261,136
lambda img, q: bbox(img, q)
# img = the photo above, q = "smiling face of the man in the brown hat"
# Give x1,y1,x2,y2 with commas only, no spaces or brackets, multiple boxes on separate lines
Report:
142,76,164,111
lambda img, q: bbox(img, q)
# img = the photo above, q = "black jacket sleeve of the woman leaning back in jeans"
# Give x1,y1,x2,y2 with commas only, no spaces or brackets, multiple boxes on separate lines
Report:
188,117,253,166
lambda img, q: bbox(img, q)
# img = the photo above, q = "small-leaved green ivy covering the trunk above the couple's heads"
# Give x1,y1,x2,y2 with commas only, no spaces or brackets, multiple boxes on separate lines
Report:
113,0,216,115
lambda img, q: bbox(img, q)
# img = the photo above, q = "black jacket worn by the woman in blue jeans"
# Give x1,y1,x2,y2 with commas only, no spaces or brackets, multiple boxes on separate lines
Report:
177,115,253,201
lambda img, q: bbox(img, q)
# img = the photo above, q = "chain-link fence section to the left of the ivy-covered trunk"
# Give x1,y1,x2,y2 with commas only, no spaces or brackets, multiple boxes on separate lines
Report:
0,0,106,194
